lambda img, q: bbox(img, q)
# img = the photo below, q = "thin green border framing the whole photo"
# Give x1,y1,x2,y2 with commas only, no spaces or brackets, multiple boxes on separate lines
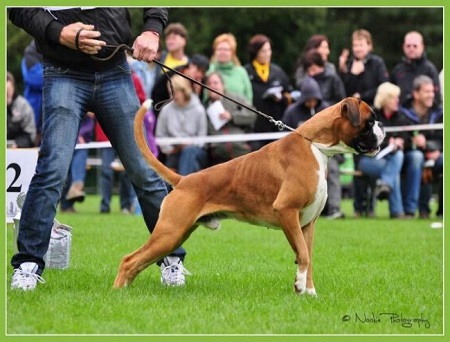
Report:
0,0,450,342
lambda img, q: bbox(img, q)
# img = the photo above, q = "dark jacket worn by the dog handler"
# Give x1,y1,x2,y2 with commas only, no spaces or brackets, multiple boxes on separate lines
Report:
8,7,168,71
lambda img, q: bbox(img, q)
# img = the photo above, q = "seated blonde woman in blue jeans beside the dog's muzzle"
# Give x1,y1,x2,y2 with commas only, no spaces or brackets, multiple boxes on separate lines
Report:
355,82,407,218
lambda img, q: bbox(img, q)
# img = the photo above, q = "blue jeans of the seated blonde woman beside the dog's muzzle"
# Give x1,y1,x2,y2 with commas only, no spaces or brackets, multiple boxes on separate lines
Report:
359,150,404,217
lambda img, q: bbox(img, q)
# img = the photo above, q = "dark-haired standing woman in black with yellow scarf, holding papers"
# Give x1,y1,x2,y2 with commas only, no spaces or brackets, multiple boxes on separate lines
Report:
245,34,292,150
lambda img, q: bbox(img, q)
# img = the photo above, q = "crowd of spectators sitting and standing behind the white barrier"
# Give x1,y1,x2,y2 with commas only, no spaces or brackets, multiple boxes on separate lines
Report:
7,23,443,219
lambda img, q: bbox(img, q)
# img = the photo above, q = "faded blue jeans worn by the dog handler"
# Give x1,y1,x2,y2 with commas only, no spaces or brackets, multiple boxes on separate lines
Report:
11,60,185,273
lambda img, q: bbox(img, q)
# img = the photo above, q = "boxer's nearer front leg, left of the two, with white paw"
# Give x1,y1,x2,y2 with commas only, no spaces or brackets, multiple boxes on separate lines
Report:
276,209,310,294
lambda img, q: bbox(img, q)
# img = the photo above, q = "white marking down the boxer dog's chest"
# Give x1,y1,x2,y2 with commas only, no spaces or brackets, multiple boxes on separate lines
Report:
300,145,328,226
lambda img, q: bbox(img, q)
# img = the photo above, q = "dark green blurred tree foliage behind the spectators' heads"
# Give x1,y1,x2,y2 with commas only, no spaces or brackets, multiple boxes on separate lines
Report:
7,7,444,92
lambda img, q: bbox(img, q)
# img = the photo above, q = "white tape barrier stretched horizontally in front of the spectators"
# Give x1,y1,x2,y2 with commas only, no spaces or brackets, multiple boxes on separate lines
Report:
75,123,444,149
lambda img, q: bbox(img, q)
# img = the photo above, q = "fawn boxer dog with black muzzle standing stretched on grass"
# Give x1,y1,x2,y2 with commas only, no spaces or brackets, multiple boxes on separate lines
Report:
114,97,385,295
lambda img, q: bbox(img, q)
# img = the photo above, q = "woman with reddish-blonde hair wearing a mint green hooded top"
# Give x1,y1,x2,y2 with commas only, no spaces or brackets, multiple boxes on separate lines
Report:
208,33,253,103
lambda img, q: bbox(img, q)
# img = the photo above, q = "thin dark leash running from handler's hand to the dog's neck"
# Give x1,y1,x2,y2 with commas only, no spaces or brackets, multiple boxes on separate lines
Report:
91,44,295,132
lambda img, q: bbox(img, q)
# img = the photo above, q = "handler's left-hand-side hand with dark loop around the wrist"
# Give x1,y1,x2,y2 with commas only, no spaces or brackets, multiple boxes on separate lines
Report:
59,22,106,55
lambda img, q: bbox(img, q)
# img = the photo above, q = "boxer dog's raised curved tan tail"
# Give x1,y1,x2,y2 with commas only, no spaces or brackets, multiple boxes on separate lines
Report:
134,100,182,186
